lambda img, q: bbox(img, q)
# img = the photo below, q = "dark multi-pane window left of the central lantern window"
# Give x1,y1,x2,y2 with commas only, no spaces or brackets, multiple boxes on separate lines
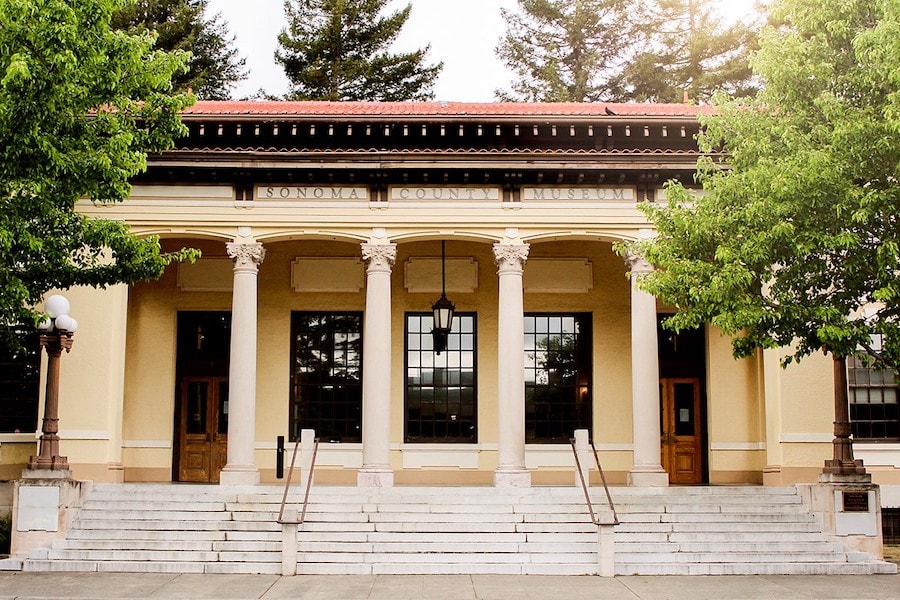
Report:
290,312,363,442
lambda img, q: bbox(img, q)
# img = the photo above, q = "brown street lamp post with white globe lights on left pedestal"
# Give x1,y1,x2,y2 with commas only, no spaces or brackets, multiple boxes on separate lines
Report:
28,295,78,471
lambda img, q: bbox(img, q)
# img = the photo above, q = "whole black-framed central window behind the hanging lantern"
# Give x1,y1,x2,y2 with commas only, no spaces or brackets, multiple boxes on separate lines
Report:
403,312,478,444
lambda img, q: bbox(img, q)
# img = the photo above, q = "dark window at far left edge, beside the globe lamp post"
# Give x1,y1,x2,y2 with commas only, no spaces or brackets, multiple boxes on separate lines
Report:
0,327,41,433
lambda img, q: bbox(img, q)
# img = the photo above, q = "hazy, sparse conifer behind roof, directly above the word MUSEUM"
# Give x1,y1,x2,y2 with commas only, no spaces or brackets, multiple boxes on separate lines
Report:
496,0,634,102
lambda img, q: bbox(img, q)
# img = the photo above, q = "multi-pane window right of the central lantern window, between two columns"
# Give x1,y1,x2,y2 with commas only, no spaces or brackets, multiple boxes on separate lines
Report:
524,313,592,443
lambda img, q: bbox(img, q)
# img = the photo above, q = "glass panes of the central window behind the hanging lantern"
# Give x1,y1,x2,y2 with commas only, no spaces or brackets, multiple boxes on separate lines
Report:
404,313,478,443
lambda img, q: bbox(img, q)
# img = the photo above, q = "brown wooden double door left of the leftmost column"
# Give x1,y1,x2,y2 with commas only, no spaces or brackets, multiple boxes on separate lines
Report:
177,377,228,483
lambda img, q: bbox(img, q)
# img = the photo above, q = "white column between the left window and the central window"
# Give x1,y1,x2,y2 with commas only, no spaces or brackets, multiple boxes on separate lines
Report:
356,243,397,487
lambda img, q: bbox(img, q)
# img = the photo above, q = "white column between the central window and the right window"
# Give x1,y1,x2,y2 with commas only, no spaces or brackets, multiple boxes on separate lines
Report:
494,244,531,487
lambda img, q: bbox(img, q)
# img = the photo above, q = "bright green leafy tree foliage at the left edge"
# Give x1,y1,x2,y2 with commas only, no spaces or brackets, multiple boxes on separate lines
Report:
0,0,193,323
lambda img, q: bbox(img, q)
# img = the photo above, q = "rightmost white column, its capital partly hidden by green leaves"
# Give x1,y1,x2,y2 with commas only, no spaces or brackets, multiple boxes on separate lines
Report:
627,255,669,486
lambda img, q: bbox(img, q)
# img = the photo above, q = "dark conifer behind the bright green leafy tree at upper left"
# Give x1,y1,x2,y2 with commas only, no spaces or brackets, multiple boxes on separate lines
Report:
112,0,247,100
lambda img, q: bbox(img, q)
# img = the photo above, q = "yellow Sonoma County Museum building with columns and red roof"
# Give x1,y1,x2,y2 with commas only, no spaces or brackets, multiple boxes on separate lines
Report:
0,102,900,496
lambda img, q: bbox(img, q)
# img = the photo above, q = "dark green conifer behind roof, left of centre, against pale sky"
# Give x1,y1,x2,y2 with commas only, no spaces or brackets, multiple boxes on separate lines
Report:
275,0,443,102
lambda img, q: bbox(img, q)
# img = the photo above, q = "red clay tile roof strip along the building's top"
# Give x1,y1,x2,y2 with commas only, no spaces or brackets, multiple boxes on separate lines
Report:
183,101,713,118
